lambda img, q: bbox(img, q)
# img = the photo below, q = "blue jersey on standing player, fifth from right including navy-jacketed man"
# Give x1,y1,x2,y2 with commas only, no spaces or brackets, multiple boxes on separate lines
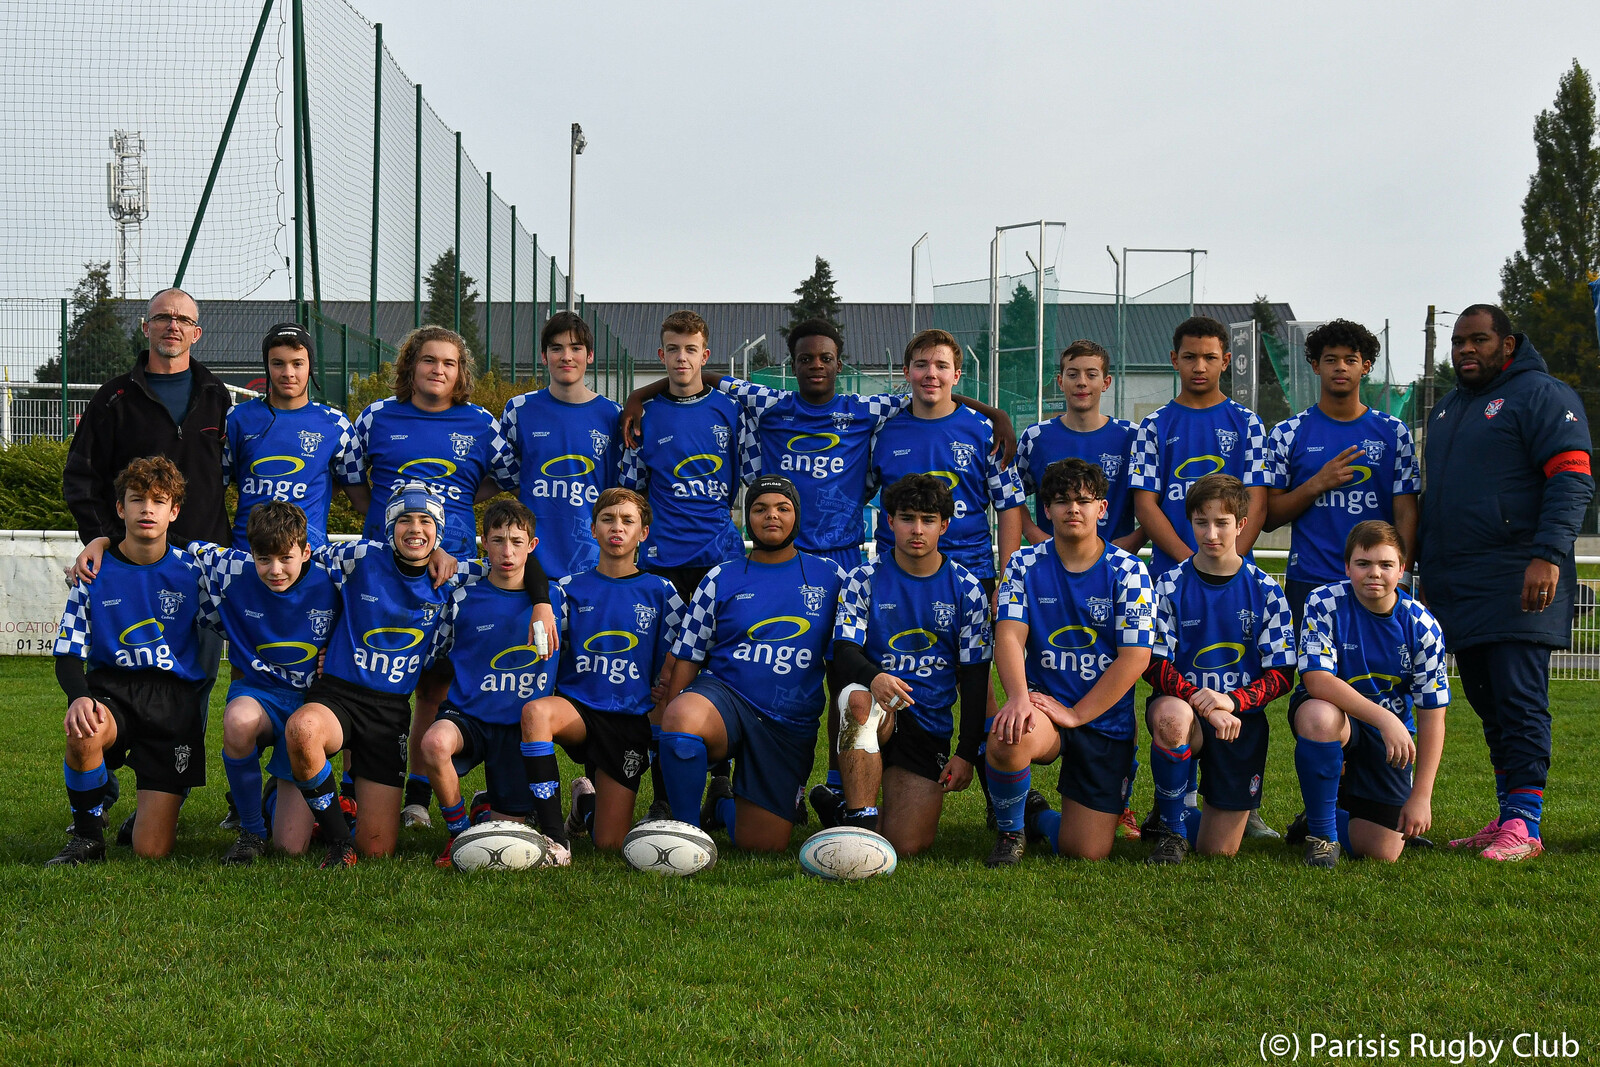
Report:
872,405,1027,577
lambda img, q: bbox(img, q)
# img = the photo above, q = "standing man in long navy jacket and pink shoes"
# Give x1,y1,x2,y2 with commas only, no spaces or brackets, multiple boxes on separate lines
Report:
1418,304,1595,859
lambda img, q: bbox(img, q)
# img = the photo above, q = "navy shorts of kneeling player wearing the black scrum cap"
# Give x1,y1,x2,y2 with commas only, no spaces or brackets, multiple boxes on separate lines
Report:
683,673,812,822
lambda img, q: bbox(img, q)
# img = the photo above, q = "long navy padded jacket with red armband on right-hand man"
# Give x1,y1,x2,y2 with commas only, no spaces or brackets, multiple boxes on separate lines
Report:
1419,334,1595,649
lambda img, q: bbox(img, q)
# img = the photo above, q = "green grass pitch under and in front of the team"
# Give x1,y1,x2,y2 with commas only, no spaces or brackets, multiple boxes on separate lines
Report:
0,659,1600,1064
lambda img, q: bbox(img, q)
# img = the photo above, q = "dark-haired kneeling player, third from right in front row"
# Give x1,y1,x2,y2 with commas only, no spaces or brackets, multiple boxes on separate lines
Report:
986,459,1155,867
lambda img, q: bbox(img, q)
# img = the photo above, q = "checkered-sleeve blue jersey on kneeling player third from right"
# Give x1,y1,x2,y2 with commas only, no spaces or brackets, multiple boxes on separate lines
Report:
998,541,1155,741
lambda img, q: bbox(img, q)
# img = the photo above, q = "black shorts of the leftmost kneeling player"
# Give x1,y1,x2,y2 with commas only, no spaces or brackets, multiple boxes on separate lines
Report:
88,669,211,793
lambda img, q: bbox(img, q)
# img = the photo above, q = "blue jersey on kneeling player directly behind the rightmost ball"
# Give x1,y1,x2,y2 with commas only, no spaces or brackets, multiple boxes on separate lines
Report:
834,553,994,737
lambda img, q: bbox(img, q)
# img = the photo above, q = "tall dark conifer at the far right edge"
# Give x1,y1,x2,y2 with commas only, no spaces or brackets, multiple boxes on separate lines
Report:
1501,59,1600,395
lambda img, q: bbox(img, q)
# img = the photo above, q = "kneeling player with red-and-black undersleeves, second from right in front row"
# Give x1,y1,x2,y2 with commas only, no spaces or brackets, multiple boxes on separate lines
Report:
1144,474,1294,864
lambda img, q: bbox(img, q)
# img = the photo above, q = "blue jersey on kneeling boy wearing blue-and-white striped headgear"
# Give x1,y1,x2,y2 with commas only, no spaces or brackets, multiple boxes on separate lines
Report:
312,541,476,696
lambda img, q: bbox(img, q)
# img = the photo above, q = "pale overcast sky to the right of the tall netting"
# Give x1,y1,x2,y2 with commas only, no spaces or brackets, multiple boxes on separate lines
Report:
354,0,1600,377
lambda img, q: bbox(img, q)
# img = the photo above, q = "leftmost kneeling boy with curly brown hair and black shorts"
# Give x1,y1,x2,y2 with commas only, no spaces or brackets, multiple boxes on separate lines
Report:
48,456,206,865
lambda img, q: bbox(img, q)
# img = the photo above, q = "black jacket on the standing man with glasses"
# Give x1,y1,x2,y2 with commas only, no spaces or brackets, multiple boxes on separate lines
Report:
61,352,232,545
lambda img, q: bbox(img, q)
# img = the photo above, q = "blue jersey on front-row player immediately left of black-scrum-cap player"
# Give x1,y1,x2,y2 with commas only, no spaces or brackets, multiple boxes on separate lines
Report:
550,571,683,715
